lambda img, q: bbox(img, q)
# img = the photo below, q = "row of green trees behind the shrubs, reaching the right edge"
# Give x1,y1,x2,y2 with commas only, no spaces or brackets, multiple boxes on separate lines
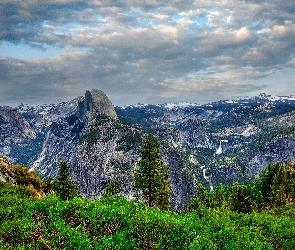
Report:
188,162,295,213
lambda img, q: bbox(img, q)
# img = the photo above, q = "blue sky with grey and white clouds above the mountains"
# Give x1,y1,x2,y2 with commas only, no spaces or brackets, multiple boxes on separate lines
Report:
0,0,295,106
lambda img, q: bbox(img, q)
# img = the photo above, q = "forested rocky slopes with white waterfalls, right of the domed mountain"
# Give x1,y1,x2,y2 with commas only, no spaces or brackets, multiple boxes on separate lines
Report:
116,94,295,188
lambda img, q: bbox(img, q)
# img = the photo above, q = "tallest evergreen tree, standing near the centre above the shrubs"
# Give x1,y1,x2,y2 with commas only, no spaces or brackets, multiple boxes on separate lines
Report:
134,133,172,209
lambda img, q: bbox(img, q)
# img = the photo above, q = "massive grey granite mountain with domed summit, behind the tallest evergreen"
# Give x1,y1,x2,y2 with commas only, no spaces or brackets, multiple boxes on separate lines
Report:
27,90,194,209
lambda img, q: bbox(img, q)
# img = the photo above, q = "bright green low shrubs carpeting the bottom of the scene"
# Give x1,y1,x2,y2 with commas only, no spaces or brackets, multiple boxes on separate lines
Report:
0,182,295,250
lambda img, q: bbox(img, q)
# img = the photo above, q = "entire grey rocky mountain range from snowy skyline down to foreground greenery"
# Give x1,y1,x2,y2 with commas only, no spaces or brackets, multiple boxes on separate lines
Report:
0,90,295,210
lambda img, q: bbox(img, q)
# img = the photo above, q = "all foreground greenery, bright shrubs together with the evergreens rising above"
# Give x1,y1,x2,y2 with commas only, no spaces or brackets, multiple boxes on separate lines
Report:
0,135,295,250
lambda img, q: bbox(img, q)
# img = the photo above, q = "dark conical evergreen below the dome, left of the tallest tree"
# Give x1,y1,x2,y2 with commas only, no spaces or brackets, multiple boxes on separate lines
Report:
53,160,80,200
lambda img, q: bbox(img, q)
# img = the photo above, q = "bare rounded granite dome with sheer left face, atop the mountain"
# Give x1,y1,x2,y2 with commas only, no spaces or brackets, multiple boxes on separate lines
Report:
79,89,118,119
